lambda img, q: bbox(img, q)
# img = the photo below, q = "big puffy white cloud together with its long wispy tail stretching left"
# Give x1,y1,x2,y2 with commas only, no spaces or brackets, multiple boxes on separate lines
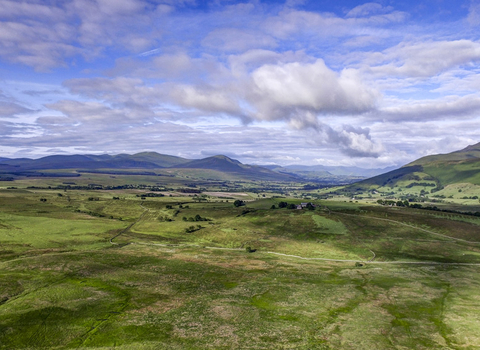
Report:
64,58,378,128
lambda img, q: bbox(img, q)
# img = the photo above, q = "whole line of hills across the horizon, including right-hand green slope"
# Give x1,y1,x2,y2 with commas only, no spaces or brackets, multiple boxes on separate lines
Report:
0,143,480,189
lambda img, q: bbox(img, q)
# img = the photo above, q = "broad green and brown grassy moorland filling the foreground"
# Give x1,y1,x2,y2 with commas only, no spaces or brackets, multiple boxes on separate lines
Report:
0,189,480,349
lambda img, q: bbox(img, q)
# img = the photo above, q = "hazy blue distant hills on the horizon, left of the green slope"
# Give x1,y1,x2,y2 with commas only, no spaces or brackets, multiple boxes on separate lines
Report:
0,152,408,185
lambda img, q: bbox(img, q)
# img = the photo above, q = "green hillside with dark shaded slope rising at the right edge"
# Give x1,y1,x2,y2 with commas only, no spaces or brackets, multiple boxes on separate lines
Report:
352,143,480,192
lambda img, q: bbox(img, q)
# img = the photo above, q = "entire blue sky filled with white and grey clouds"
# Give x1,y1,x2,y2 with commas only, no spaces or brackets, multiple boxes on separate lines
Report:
0,0,480,168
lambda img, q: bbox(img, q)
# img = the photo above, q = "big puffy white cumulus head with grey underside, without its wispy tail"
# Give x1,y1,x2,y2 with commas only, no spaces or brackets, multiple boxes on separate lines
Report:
248,59,377,126
